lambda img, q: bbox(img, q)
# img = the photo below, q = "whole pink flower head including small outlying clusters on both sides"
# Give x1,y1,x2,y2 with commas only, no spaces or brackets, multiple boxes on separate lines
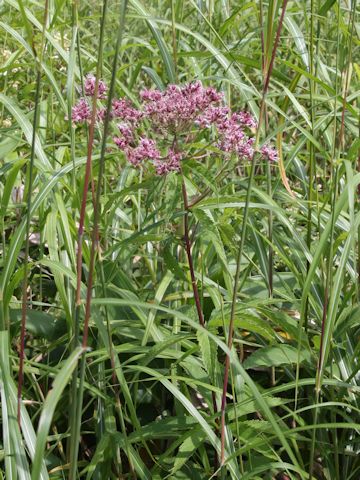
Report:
72,75,277,175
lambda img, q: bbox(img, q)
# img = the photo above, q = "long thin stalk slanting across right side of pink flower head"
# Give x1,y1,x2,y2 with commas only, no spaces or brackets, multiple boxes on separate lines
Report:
220,0,288,465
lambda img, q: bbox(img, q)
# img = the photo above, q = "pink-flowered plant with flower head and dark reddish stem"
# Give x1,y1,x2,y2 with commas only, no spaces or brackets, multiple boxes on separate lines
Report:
72,76,277,463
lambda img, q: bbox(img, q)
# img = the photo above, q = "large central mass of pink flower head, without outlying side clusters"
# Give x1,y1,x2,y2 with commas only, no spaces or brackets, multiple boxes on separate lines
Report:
109,81,262,175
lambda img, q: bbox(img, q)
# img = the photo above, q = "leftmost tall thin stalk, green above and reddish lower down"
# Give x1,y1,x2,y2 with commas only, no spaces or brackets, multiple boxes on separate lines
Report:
17,0,48,427
